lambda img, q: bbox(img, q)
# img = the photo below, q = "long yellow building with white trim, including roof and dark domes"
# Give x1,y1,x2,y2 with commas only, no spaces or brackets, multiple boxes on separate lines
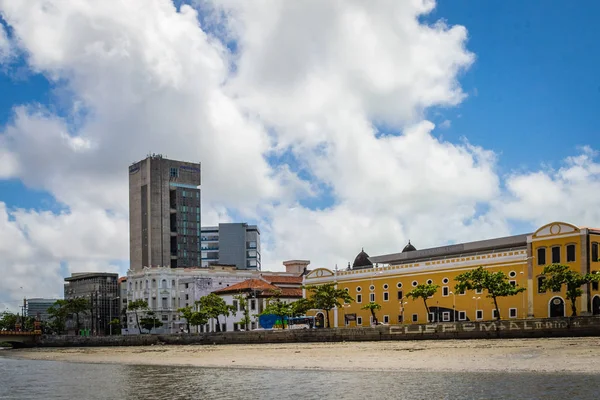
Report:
304,222,600,327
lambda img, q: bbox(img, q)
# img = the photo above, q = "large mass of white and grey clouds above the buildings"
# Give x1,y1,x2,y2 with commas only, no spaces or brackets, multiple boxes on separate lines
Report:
0,0,598,310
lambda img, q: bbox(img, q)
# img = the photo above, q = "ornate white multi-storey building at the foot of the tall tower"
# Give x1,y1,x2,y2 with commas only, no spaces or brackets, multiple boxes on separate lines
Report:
123,265,308,334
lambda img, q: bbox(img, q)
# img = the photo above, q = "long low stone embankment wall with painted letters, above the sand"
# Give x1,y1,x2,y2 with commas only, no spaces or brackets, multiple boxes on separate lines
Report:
37,317,600,347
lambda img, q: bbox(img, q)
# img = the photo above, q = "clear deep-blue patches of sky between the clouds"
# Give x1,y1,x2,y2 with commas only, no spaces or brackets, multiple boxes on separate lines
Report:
0,0,600,209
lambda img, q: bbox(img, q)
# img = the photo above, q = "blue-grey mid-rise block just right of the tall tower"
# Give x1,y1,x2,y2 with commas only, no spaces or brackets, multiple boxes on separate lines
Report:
201,223,261,271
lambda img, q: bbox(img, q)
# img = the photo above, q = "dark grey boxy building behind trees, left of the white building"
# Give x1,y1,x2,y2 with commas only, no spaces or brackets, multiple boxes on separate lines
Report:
64,272,119,335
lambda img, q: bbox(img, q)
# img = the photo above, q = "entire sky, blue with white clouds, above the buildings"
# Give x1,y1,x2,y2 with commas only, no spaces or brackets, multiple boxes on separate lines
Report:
0,0,600,311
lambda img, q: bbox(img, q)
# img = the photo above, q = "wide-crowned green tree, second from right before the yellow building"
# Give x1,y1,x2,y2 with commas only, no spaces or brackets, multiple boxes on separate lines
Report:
454,267,525,320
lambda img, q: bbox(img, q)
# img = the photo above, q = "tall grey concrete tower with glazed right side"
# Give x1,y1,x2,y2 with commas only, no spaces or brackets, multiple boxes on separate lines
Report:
129,154,202,271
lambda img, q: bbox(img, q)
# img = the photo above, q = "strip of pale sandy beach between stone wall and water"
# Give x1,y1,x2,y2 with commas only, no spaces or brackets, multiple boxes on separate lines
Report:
2,338,600,373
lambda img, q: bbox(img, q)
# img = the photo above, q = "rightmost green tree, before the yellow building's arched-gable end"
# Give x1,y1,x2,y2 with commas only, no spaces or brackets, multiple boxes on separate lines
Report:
542,264,600,317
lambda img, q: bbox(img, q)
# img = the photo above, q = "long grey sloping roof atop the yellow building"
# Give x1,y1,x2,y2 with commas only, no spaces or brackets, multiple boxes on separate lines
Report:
369,233,531,264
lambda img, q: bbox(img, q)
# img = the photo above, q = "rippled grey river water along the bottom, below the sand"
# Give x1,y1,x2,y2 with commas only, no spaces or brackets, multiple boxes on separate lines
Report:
0,351,600,400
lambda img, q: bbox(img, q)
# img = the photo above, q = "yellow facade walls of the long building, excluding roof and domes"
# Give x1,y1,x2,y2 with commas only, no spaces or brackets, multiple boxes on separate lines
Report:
305,223,600,326
